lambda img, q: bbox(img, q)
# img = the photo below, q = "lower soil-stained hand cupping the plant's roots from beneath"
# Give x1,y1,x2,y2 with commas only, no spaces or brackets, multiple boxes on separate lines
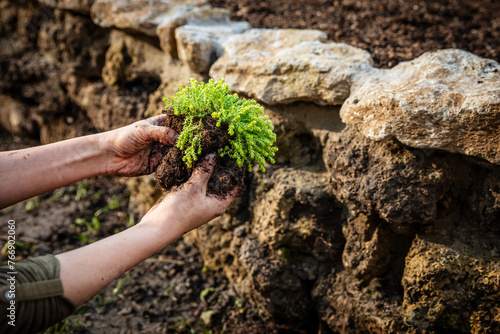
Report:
141,154,238,237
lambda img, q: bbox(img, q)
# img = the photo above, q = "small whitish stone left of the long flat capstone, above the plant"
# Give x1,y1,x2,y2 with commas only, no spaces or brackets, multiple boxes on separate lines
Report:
175,7,250,73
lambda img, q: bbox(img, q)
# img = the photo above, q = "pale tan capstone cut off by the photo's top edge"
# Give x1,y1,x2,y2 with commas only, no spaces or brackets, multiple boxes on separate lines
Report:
91,0,206,36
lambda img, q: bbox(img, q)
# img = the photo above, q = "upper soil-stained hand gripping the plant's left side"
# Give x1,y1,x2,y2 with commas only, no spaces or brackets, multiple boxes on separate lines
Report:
101,115,177,176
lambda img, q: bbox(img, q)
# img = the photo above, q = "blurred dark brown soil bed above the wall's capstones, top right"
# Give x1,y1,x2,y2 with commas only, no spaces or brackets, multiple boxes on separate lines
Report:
209,0,500,67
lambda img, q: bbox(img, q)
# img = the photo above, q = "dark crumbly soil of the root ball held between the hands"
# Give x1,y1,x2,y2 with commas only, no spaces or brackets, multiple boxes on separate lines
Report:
155,109,245,198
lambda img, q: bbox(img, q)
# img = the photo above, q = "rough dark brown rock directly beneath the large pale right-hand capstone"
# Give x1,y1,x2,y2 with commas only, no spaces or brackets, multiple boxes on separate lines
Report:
325,127,456,228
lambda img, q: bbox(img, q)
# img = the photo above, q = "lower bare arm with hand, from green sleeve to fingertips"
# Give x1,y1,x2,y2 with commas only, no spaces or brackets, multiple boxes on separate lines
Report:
56,156,235,306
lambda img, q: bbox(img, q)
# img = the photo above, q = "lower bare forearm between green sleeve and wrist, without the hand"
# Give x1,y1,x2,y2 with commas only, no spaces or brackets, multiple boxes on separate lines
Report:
56,218,183,306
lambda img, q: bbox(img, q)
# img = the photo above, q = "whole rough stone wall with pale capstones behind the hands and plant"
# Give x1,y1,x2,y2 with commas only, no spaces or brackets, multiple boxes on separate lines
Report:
0,0,500,333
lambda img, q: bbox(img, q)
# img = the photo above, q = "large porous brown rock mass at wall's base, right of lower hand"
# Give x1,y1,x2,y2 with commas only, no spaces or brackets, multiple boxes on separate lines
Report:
185,168,345,325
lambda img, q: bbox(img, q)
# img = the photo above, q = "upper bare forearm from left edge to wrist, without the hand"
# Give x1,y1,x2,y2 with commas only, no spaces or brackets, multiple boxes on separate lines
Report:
0,134,106,208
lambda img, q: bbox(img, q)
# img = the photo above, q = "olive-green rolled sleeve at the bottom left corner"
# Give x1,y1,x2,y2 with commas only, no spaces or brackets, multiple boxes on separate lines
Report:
0,255,75,333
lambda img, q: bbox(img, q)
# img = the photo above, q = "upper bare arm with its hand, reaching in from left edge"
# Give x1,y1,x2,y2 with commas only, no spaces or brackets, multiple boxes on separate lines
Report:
0,115,176,209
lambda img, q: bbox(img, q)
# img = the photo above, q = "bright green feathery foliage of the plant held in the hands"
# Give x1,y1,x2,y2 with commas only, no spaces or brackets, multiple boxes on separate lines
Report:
163,79,278,171
